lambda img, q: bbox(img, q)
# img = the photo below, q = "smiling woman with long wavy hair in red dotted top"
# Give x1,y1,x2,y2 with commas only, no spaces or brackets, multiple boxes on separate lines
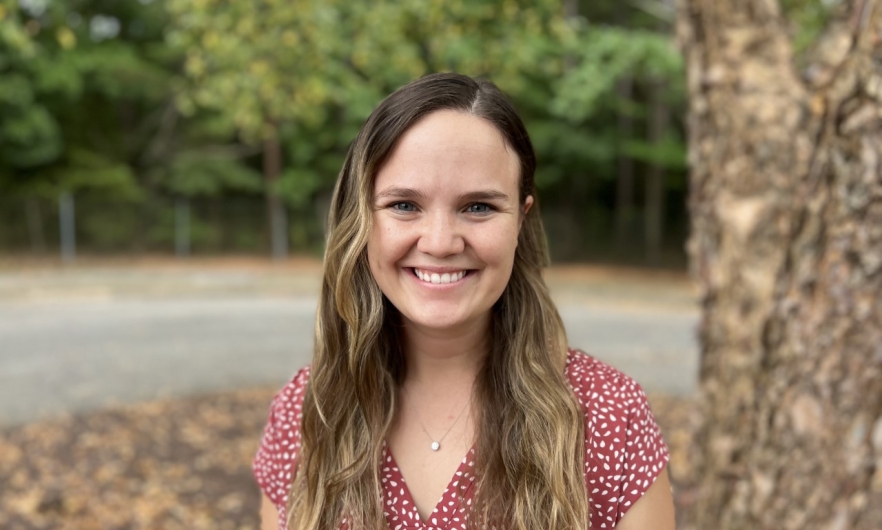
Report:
254,74,674,530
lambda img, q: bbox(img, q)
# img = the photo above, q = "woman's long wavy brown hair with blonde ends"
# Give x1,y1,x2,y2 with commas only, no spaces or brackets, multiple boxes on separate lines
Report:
288,74,588,530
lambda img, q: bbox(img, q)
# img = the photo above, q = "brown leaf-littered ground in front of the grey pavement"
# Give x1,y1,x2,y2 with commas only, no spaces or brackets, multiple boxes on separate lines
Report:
0,389,695,530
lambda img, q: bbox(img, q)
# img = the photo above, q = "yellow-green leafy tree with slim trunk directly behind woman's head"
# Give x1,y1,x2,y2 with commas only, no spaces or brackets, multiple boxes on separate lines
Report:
169,0,567,256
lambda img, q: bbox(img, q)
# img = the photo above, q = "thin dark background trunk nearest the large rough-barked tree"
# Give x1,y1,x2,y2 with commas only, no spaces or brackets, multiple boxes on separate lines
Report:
643,82,670,266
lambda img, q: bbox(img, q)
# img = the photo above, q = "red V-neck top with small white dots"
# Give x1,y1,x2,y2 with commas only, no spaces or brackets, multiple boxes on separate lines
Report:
253,350,669,530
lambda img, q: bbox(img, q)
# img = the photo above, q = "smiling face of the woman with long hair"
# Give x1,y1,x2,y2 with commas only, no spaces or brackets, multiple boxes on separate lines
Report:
367,110,533,330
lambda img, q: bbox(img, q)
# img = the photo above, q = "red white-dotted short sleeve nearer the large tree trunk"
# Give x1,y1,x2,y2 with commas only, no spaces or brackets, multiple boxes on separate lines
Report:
567,352,669,529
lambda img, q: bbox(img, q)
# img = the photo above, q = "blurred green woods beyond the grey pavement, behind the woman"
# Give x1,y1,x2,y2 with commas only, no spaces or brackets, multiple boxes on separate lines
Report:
0,0,696,268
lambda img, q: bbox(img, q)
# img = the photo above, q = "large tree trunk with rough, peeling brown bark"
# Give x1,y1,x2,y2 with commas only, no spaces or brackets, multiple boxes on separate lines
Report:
678,0,882,530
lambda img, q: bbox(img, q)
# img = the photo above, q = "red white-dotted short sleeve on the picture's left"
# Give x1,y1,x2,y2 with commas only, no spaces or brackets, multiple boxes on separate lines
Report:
251,367,309,529
